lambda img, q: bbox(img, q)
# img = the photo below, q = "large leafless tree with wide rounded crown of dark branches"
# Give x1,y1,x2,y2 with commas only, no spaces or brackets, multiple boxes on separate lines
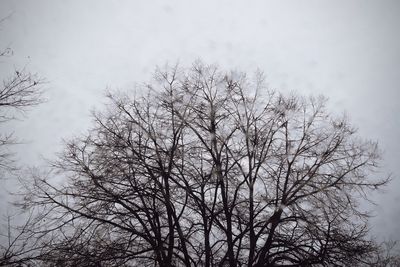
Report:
23,63,387,266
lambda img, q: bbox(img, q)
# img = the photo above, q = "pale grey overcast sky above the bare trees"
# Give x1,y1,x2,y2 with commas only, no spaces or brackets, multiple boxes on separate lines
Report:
0,0,400,242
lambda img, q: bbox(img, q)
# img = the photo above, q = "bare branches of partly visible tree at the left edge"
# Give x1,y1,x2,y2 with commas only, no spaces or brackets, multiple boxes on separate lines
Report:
0,23,43,266
